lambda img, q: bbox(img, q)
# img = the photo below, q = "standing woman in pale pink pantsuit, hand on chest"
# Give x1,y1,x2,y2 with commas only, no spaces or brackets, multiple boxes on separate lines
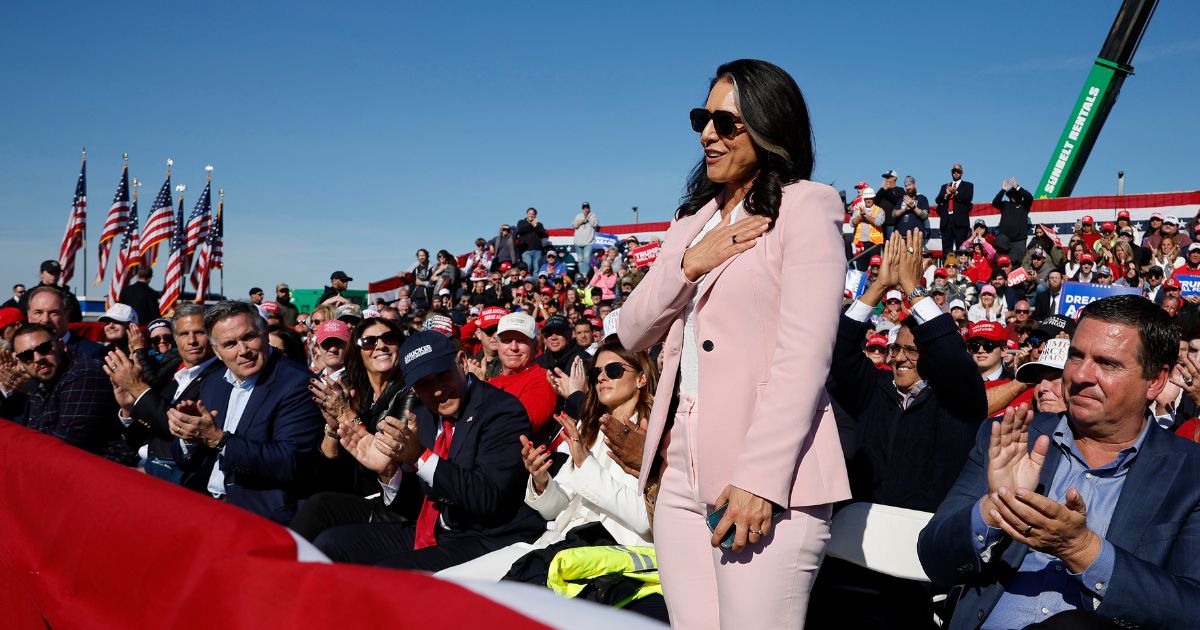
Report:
619,60,850,630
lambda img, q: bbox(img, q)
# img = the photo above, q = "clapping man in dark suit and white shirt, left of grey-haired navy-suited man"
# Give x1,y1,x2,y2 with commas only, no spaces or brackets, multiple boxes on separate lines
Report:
104,304,226,484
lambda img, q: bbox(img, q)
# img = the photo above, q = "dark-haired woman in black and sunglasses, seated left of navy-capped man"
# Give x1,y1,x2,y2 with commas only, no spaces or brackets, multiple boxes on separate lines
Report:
290,317,420,540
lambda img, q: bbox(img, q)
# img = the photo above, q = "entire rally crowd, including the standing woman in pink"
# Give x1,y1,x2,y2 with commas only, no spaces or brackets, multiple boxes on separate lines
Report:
0,60,1200,629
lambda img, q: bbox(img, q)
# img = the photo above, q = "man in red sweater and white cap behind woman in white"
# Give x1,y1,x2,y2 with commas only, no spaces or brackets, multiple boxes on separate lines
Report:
488,312,558,444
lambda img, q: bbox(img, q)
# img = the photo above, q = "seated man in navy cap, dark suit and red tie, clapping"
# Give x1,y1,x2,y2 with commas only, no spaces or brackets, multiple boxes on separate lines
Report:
316,331,546,571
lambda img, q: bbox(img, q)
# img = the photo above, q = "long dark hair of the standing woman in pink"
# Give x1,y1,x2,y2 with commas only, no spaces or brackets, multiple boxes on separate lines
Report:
676,59,816,224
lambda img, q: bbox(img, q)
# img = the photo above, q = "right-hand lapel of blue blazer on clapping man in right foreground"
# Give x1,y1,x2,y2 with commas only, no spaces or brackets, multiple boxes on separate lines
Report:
1104,420,1183,550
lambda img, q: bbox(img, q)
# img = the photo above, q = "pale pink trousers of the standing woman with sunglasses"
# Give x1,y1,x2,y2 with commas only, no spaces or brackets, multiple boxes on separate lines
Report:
654,396,832,630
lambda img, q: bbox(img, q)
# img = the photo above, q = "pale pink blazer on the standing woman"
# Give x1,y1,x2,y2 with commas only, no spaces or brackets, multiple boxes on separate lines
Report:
618,181,850,508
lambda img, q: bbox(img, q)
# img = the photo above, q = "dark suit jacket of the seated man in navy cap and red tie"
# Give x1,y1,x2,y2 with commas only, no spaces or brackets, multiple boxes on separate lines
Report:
415,378,546,540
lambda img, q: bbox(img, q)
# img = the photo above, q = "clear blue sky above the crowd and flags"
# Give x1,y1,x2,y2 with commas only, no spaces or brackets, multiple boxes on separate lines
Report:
0,0,1200,302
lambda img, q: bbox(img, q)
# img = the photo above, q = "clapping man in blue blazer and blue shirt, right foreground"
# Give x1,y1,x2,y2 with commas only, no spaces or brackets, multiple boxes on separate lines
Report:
918,295,1200,629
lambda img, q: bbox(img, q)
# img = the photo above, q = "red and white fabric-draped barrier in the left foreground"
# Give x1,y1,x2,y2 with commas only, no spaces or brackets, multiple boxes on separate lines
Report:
0,420,667,630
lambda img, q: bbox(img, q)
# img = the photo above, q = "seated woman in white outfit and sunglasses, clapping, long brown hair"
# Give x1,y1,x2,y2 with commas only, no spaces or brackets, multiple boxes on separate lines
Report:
438,338,658,581
